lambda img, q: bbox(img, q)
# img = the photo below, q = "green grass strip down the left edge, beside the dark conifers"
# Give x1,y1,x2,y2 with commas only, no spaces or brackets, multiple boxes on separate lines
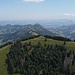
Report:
0,45,10,75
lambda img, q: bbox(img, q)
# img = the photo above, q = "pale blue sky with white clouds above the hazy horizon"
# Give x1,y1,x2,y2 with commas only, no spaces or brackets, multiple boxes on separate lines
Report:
0,0,75,20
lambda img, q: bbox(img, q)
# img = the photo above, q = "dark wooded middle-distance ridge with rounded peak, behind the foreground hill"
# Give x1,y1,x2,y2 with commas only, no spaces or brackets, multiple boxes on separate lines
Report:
0,24,57,44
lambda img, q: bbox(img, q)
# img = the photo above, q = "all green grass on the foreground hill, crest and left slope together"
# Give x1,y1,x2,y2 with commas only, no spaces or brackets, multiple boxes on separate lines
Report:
0,36,75,75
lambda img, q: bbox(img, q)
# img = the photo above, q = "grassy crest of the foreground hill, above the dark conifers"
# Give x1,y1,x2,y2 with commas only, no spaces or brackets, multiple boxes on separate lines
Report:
22,36,75,51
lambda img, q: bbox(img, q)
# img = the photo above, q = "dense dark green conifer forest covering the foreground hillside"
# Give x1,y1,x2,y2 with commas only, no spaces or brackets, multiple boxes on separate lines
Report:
6,40,75,75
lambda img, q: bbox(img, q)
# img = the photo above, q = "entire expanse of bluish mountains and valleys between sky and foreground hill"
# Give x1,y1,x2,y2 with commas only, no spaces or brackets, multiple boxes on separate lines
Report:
0,19,75,45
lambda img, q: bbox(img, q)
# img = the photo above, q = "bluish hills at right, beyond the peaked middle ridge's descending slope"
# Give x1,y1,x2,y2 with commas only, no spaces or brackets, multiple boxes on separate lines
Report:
47,24,75,40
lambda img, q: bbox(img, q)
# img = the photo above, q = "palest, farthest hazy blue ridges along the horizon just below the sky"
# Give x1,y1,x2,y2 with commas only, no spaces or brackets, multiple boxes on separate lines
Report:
0,19,75,28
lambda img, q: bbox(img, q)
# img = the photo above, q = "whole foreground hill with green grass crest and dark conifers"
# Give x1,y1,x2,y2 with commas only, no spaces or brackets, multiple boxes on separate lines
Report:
0,36,75,75
